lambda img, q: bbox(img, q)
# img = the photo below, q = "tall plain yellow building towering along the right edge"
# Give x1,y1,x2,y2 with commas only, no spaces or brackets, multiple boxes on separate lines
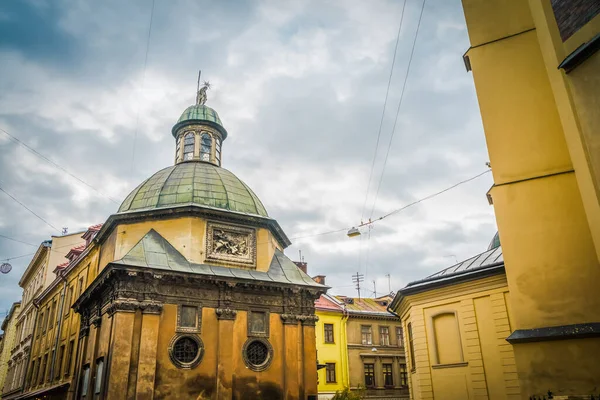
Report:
458,0,600,398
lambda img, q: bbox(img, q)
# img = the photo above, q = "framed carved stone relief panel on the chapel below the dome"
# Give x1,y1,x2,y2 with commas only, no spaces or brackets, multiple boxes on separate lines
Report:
206,222,256,267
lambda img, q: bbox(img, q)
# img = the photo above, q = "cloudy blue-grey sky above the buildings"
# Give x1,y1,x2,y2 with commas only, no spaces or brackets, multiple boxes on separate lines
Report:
0,0,496,318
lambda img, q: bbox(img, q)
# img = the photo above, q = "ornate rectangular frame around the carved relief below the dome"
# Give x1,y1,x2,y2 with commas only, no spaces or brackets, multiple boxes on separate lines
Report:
206,221,256,268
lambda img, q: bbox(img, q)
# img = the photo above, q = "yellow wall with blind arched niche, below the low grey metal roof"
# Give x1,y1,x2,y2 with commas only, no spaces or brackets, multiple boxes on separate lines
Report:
397,275,521,400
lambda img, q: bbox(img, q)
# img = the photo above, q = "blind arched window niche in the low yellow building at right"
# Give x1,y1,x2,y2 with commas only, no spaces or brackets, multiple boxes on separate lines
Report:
432,312,463,364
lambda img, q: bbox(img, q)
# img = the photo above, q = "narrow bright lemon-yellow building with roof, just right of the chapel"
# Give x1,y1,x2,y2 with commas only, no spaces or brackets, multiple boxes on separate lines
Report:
315,294,350,399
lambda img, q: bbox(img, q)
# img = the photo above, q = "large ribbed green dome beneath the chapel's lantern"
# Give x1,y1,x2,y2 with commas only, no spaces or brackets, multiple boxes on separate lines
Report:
118,162,268,217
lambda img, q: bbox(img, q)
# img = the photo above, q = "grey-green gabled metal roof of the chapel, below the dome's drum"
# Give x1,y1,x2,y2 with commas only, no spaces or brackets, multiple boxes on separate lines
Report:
112,229,327,289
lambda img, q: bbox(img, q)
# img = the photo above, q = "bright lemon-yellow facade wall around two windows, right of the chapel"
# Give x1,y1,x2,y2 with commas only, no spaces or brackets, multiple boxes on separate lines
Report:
315,310,350,398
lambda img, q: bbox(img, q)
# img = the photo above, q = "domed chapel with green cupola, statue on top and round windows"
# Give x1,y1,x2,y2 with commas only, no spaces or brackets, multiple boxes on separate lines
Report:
73,84,327,400
